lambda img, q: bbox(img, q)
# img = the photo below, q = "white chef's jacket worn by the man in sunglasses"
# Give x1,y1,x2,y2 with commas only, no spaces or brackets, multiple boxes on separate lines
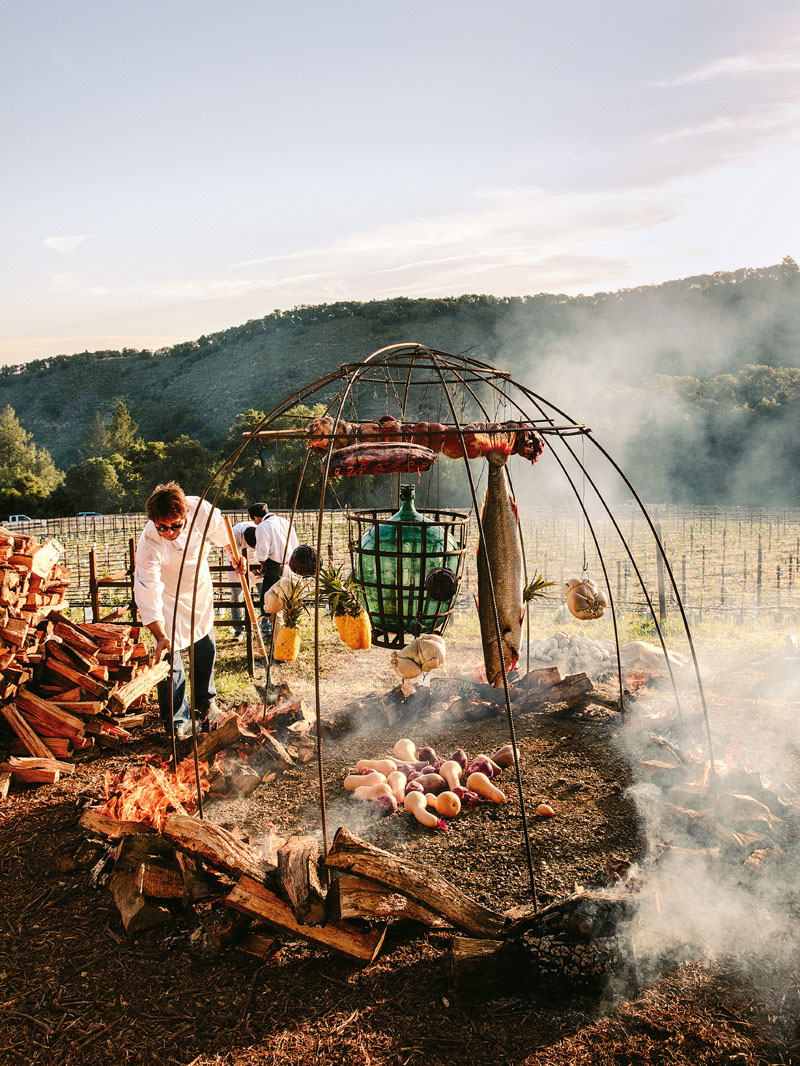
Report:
133,496,228,651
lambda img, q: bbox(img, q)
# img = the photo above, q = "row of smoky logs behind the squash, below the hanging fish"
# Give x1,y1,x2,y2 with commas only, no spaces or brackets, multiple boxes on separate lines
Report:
324,666,608,737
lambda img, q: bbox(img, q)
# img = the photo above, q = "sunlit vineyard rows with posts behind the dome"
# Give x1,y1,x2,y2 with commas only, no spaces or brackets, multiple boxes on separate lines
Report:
42,505,800,625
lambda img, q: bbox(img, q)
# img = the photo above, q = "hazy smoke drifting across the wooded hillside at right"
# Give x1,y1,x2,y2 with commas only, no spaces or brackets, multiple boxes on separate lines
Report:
496,262,800,504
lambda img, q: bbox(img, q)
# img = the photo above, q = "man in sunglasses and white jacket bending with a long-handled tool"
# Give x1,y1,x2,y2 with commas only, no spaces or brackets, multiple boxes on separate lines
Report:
133,481,243,740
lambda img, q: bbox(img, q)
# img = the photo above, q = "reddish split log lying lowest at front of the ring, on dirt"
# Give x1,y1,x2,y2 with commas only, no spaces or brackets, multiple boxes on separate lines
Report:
225,877,386,963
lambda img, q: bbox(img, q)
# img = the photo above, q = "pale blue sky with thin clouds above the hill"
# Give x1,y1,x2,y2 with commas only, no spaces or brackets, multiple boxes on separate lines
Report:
0,0,800,364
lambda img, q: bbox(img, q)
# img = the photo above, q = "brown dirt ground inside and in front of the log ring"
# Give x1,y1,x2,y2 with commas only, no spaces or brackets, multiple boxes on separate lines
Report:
0,626,800,1066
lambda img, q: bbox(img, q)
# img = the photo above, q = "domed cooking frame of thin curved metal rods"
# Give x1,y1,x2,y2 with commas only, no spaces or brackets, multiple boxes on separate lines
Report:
170,342,717,904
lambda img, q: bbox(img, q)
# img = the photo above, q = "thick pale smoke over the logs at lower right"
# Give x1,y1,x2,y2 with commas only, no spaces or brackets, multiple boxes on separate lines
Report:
620,669,800,985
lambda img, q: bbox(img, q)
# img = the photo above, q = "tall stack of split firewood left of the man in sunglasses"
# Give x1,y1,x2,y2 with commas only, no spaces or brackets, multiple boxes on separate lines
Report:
0,527,169,795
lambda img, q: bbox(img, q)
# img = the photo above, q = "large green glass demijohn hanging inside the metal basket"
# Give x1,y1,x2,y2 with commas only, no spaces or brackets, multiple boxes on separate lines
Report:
355,485,461,636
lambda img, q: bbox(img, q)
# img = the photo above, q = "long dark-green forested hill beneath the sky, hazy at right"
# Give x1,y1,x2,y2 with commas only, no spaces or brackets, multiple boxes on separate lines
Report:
0,258,800,468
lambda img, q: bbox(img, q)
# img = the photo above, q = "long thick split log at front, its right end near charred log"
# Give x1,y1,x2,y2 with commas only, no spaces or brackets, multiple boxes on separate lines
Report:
325,826,503,938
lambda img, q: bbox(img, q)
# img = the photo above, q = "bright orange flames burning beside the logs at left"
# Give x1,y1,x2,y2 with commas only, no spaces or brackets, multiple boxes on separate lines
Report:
96,756,209,830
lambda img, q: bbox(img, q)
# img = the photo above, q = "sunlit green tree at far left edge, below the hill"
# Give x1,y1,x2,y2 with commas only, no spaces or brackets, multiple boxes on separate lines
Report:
0,404,64,514
